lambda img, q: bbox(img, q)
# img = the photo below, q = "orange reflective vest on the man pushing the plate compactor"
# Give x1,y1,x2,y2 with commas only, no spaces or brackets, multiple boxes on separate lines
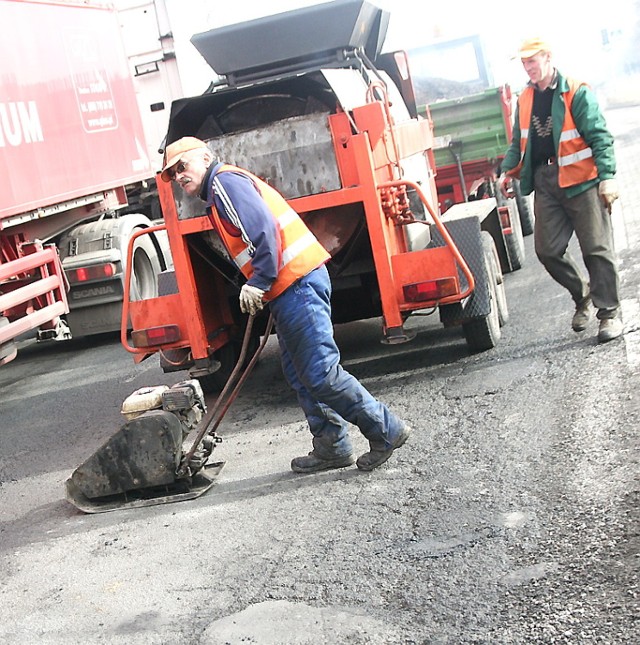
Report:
209,164,331,301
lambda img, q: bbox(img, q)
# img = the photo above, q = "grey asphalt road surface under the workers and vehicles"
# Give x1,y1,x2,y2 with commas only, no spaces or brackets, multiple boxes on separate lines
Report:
0,107,640,645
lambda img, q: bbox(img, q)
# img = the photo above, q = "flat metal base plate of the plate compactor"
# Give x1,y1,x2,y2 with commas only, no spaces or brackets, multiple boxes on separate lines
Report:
66,461,225,513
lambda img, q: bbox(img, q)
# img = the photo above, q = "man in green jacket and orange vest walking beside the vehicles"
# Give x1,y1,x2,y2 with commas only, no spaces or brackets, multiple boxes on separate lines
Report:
498,38,622,342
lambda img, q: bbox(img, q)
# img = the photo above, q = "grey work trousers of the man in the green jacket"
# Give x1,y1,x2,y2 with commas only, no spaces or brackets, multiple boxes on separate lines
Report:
534,164,620,319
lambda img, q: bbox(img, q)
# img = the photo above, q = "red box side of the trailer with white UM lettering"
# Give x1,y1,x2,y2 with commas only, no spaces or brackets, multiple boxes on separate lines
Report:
0,0,153,221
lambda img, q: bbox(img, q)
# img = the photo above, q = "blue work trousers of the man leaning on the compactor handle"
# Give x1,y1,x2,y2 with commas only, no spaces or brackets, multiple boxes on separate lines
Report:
269,266,404,458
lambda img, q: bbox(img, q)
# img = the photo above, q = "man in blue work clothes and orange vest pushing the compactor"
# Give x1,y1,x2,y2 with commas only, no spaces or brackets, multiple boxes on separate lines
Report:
161,137,410,473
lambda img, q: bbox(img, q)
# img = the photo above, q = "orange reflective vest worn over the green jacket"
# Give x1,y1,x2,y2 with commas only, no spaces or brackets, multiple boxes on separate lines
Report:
506,79,598,188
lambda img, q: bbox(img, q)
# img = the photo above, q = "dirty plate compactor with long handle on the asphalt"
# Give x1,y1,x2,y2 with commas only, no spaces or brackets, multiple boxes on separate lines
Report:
66,316,273,513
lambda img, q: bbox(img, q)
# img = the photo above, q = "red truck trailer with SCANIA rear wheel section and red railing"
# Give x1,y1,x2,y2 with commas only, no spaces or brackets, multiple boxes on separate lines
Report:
0,0,167,364
